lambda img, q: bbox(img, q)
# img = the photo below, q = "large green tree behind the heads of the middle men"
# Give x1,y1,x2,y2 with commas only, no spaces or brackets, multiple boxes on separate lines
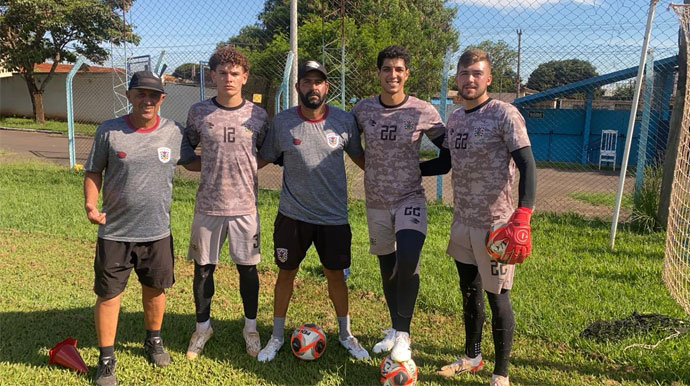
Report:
221,0,458,100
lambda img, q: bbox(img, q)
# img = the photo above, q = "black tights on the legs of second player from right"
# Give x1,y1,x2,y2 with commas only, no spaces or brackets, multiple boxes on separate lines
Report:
379,230,426,333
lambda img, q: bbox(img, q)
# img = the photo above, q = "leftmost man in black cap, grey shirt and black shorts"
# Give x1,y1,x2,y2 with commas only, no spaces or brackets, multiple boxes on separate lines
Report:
84,71,201,385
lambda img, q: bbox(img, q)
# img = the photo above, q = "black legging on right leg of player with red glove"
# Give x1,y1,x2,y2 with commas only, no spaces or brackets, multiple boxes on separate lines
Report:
487,290,515,377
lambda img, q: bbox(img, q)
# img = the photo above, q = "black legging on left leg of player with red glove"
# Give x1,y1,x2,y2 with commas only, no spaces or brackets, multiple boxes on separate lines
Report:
455,261,484,358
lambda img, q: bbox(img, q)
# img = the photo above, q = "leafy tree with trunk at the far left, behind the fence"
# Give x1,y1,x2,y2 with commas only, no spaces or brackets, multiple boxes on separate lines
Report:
0,0,139,124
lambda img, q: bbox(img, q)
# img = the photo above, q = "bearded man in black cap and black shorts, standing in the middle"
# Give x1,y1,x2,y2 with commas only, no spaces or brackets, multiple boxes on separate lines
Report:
258,60,369,362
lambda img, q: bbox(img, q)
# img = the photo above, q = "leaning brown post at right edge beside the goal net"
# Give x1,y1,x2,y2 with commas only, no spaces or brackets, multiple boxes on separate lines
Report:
656,8,690,229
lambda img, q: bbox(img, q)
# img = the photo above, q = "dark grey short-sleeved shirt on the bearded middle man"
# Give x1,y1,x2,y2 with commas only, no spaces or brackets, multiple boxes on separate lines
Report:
259,105,364,225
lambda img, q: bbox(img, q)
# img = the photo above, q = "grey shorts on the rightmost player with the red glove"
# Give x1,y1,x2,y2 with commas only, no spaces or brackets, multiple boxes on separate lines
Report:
446,219,515,294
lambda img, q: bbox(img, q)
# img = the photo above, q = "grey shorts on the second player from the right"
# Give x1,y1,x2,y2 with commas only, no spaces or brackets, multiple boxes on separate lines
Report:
367,197,427,255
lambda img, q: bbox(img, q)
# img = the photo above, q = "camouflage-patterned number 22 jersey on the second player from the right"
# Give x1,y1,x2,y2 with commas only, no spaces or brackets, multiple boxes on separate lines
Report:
352,96,445,209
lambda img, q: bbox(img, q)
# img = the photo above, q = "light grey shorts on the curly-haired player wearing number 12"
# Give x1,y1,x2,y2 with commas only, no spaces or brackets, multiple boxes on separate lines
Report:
187,212,261,265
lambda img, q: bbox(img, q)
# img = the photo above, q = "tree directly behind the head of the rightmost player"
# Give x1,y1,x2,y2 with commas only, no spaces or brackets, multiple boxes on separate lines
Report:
466,40,517,92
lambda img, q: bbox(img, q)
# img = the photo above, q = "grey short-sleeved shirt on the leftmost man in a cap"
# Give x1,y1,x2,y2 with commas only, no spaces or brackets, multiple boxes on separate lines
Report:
84,116,196,242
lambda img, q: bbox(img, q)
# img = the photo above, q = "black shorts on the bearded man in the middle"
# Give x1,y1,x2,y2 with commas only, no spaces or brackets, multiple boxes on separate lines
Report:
273,212,352,270
